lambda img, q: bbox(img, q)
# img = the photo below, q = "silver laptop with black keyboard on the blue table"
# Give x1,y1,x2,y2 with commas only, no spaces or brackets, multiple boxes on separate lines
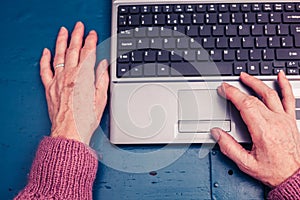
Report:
110,0,300,144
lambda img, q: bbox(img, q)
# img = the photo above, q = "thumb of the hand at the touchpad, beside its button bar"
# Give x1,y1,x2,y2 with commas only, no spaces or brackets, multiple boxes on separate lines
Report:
211,128,256,173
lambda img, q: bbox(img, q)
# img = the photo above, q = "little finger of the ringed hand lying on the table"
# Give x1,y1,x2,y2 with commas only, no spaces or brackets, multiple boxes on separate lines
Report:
40,48,53,88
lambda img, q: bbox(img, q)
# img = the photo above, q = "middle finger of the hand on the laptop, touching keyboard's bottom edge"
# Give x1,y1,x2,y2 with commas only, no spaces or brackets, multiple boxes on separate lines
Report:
240,73,284,113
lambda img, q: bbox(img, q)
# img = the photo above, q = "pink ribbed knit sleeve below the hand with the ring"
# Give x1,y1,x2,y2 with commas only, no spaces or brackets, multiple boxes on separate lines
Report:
15,137,98,200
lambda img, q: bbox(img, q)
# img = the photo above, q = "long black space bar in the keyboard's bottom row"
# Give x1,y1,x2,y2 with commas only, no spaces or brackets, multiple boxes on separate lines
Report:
171,62,233,76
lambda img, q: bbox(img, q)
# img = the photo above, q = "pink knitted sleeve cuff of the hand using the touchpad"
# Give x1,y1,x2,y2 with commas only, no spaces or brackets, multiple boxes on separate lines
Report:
268,169,300,200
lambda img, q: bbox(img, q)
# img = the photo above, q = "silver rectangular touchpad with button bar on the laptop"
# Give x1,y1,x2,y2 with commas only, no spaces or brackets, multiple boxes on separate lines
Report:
178,89,230,132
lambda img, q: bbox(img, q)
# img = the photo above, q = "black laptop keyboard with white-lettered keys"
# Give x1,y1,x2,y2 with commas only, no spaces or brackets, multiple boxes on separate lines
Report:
116,3,300,78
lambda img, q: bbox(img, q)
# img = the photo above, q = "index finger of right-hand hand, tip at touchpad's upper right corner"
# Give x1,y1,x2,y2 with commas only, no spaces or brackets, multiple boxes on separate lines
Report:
218,83,269,138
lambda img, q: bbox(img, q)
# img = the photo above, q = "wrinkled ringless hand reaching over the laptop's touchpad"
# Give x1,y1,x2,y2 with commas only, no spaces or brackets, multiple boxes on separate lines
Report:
211,72,300,187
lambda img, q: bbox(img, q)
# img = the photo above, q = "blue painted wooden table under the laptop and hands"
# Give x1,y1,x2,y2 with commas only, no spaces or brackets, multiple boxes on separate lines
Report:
0,0,265,200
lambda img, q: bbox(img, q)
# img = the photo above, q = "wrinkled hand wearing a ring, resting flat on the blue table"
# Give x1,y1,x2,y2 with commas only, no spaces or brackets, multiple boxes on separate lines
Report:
40,22,109,144
